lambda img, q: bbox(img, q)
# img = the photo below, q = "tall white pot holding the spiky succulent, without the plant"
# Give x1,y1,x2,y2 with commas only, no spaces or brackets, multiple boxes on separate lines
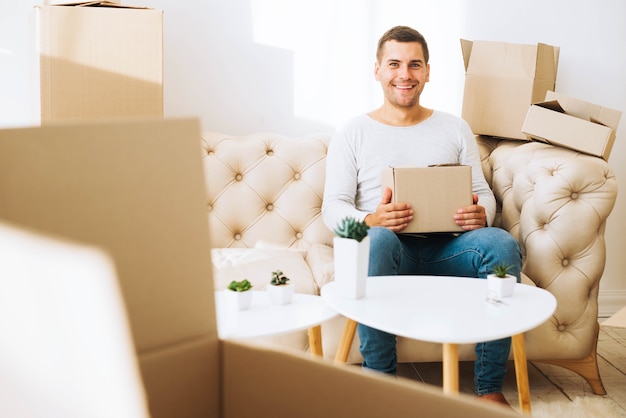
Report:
333,236,370,299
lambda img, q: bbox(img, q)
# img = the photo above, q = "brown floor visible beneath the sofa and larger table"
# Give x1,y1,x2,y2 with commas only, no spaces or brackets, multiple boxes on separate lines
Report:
399,327,626,418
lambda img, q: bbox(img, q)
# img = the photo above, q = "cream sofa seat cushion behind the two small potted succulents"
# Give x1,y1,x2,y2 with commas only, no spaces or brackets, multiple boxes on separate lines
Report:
211,248,316,294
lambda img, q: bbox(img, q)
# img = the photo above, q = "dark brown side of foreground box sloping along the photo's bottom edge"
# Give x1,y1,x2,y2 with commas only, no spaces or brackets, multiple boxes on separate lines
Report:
221,340,519,418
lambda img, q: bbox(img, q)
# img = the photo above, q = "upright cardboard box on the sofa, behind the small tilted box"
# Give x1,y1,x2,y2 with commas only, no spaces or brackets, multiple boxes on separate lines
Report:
461,40,559,140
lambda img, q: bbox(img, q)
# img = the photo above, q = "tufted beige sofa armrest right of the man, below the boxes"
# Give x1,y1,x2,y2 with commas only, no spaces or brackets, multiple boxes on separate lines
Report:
477,137,617,358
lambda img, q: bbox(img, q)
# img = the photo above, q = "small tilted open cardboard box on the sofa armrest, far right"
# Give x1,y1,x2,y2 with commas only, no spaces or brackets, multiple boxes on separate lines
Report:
522,91,622,161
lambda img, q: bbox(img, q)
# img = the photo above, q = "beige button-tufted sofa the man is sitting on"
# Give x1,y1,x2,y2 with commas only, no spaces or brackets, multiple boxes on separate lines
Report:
203,132,617,394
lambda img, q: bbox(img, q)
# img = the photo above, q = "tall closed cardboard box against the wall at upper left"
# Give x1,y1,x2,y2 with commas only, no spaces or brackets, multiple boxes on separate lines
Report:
35,2,163,124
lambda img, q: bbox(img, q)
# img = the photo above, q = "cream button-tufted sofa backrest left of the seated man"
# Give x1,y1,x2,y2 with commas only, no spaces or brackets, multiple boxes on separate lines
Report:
202,132,333,250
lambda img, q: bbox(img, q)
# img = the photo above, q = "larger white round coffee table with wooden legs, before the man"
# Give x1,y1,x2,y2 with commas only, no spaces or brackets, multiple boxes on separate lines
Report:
321,276,556,412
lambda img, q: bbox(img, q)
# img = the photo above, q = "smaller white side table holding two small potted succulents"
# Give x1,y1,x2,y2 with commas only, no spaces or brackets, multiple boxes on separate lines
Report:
215,290,338,357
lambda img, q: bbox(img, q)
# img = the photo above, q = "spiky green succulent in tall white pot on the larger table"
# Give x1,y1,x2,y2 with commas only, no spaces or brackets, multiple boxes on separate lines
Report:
333,217,370,299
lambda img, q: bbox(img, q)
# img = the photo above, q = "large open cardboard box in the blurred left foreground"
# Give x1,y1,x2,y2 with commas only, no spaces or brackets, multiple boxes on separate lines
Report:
0,120,517,418
